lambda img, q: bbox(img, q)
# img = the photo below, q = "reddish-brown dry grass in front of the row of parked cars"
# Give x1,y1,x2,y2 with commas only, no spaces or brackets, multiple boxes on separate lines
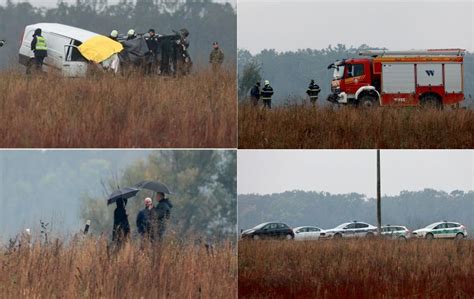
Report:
239,239,474,298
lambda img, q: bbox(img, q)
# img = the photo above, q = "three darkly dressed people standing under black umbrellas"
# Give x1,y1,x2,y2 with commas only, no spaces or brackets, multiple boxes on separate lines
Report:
112,193,173,244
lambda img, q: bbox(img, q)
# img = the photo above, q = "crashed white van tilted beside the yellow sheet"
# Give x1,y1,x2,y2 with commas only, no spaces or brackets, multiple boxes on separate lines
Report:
18,23,99,77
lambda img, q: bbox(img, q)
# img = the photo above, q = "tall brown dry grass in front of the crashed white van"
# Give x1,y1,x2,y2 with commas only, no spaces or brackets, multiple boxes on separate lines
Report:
0,69,237,148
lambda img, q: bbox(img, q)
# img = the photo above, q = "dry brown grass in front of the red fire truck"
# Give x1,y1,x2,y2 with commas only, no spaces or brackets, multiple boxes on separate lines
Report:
239,104,474,149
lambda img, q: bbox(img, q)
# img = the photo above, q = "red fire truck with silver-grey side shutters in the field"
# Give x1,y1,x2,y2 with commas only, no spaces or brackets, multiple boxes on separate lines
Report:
328,49,465,107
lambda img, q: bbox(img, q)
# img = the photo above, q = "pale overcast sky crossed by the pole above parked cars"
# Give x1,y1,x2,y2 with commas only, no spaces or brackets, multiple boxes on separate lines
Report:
237,150,474,197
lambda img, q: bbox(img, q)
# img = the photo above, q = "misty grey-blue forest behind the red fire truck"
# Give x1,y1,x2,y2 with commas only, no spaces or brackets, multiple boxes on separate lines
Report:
238,44,474,106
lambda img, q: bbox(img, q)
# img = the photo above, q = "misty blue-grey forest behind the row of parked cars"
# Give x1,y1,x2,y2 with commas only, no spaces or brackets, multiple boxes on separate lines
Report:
238,189,474,235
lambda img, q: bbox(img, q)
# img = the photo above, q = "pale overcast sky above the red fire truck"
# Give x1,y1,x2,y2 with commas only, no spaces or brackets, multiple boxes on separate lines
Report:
241,0,474,54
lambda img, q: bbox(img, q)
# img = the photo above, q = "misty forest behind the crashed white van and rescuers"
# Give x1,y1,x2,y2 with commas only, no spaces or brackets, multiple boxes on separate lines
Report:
0,0,237,69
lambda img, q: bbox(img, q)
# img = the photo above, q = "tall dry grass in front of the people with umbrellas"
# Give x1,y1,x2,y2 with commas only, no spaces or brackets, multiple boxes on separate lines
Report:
0,239,237,298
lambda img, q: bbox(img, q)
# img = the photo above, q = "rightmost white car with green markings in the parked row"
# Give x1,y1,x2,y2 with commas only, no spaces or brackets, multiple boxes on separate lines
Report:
413,221,467,240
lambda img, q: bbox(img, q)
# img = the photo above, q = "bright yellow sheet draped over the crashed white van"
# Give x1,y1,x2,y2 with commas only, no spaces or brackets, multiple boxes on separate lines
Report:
79,35,123,63
